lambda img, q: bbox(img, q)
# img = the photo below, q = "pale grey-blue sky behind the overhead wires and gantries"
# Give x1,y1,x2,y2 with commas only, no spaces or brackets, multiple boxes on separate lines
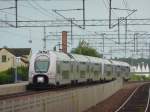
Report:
0,0,150,57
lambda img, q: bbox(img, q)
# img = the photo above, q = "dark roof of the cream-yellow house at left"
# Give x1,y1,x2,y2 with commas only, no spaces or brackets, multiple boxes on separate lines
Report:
0,48,31,57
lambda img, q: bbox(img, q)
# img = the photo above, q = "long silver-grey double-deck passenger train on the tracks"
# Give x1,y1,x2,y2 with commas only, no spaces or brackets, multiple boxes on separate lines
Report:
27,51,130,89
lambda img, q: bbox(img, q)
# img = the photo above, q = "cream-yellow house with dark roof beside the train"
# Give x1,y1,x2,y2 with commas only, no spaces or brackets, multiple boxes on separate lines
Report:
0,48,32,71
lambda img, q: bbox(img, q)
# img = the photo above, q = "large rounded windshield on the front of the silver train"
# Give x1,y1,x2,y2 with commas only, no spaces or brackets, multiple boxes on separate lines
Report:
34,56,50,73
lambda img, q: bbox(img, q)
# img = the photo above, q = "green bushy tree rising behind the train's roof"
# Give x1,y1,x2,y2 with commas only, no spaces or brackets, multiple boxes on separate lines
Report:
71,40,103,58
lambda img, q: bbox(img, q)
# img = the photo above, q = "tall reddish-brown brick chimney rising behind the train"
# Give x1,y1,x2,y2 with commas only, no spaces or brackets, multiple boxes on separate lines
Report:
62,31,67,53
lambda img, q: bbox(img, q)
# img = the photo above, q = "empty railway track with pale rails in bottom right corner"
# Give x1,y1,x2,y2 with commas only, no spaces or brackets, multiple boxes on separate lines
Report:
115,83,150,112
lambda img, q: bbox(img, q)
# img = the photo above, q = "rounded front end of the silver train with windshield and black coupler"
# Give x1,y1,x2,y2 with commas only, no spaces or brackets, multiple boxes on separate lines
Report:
27,52,55,89
